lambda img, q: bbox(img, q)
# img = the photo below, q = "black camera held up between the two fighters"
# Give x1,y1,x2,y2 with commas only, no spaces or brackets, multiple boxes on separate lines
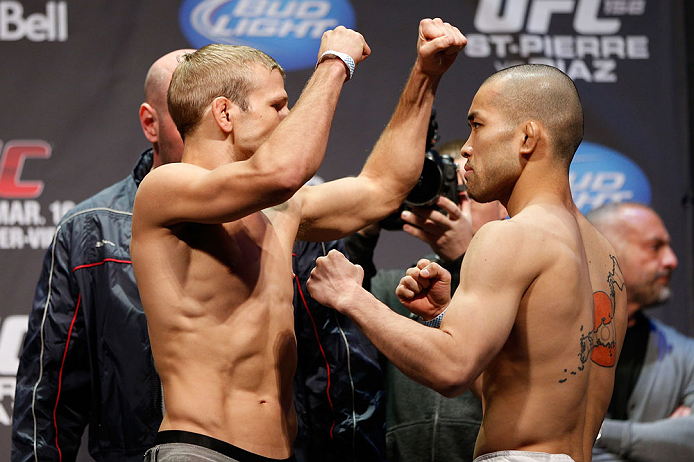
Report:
379,109,465,231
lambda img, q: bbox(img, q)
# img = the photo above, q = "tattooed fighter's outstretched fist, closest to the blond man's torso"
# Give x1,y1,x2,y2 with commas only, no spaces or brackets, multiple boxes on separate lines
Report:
306,249,365,313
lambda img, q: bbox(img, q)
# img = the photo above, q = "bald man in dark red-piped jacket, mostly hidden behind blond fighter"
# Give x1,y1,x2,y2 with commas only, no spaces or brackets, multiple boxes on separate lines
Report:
12,50,193,462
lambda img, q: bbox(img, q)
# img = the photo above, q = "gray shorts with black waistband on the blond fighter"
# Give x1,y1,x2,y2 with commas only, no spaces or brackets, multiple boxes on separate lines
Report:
144,430,296,462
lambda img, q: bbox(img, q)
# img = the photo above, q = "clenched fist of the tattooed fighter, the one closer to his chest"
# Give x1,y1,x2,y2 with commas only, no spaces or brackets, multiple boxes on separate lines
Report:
395,258,451,321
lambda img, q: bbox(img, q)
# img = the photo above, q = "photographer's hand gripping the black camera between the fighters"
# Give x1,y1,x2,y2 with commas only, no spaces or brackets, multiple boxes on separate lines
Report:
400,196,473,261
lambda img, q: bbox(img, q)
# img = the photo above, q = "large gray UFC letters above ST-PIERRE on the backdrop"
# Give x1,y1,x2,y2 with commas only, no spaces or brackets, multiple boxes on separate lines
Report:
474,0,622,35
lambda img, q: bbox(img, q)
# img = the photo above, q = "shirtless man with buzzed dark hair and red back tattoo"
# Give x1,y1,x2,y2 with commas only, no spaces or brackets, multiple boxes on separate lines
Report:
308,65,626,462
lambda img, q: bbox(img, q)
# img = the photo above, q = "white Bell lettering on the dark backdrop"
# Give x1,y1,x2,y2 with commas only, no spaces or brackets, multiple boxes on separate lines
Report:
0,1,67,42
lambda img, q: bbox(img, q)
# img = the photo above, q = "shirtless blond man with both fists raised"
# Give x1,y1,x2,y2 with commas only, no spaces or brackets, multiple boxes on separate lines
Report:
131,19,465,461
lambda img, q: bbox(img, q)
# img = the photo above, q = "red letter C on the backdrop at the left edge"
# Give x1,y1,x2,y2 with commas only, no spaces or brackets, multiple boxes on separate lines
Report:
0,140,51,199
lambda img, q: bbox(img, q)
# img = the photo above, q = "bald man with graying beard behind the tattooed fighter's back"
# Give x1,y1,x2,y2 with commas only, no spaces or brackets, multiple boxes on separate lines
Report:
586,202,694,462
